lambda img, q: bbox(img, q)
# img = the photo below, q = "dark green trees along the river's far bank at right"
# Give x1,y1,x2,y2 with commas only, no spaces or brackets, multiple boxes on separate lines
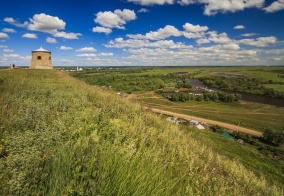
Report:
200,76,284,99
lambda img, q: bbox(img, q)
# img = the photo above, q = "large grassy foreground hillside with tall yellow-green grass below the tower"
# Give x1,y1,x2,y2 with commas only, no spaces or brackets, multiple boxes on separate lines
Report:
0,70,283,195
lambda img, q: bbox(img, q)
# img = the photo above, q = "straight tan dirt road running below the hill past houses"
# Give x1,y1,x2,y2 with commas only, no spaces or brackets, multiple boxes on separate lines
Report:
151,108,262,137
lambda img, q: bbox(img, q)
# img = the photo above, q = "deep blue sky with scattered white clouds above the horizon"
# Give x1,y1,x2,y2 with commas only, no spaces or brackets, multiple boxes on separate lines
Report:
0,0,284,66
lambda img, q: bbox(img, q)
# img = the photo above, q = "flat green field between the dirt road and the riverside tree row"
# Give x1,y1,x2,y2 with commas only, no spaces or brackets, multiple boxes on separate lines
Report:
134,93,284,132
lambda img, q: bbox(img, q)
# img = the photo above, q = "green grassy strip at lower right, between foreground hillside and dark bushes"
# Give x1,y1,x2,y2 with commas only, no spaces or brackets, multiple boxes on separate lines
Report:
186,129,284,185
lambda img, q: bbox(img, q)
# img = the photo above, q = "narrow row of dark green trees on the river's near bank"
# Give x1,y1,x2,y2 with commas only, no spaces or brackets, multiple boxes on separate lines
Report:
164,92,241,103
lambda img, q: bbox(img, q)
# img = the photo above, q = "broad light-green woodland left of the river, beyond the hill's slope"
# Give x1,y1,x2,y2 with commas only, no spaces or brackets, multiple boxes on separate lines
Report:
71,69,196,92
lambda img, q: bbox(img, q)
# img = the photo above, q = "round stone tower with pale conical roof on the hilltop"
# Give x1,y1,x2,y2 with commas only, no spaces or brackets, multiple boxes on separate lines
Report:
30,47,53,69
